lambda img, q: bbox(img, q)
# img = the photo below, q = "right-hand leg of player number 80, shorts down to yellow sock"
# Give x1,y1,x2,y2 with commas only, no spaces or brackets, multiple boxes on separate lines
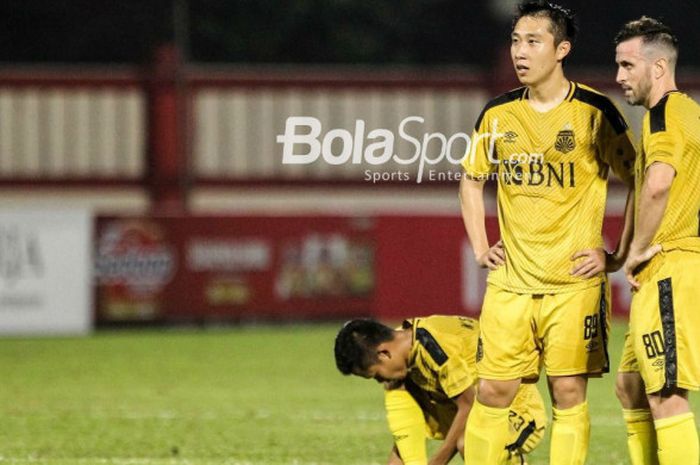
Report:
630,251,700,465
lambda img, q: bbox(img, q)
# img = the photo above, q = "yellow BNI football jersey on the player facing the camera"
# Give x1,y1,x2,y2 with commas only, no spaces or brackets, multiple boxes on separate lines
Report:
463,82,635,294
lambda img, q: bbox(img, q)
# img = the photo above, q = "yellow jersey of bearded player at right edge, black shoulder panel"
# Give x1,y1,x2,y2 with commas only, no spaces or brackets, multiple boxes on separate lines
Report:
635,91,700,251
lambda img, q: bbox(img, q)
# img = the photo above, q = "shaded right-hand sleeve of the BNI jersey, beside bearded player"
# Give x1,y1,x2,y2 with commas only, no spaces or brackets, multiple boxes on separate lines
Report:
598,102,637,186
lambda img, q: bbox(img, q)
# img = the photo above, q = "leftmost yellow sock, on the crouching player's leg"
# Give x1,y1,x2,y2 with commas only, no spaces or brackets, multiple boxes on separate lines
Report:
384,389,428,465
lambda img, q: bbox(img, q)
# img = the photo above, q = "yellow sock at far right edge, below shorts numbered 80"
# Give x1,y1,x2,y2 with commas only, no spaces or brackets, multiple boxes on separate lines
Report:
654,413,700,465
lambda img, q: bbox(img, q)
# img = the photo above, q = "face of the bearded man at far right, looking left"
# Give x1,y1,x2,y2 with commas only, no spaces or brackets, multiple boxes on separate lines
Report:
615,37,652,105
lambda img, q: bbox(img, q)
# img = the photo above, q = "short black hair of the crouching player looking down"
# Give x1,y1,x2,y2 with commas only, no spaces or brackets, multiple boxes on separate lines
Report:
335,318,394,375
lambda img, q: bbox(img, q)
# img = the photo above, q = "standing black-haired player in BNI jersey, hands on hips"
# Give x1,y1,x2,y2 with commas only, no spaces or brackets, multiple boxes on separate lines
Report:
460,2,635,465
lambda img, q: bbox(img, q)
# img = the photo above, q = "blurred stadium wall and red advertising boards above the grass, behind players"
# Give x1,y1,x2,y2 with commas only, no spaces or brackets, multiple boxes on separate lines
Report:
0,0,700,333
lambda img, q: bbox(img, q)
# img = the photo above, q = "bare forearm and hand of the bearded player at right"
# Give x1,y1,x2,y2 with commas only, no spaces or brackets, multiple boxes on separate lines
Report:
624,162,676,289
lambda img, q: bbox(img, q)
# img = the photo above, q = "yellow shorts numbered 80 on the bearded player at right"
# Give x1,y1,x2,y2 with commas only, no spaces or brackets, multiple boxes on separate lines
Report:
620,250,700,394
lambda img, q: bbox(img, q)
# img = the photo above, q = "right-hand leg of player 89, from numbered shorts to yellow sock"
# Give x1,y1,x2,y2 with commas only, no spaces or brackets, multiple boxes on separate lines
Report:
536,283,610,465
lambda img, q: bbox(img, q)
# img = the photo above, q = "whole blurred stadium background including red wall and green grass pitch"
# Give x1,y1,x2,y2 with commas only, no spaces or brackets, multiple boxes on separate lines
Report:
0,0,700,464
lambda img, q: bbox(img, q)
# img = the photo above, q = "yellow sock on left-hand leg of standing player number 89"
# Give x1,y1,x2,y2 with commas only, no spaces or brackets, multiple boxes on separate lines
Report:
464,400,510,465
